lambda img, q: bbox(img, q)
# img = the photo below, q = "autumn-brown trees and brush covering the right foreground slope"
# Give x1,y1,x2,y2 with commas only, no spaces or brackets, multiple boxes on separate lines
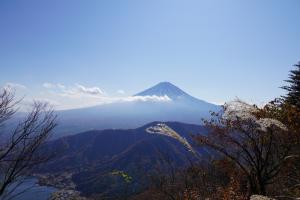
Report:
133,63,300,200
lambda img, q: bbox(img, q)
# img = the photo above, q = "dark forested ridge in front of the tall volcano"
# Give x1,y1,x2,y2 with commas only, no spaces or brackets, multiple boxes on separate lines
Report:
40,122,208,199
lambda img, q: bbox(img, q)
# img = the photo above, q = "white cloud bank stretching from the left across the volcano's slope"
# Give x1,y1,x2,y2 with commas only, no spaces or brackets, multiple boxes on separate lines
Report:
5,82,172,110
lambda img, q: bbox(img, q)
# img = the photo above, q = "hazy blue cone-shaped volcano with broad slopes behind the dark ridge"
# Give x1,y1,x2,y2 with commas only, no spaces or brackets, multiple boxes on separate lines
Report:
54,82,220,138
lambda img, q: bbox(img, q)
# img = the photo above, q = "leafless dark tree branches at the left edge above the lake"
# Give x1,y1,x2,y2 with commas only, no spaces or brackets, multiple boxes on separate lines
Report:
0,89,56,197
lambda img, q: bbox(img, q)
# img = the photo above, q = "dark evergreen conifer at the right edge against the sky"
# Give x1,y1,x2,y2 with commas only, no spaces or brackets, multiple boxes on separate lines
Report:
282,62,300,108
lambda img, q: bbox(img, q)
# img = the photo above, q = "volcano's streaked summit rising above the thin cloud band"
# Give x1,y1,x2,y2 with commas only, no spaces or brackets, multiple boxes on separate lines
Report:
135,82,188,99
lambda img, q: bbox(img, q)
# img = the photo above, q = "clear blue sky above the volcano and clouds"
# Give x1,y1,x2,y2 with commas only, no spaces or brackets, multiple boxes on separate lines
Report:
0,0,300,108
